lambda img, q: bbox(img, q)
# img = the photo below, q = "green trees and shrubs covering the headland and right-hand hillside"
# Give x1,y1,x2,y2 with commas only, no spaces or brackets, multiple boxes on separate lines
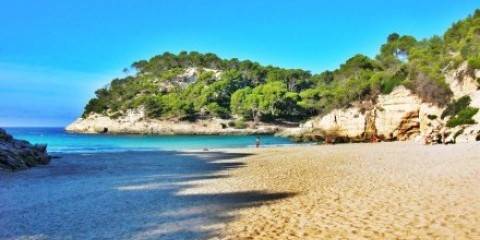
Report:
83,10,480,123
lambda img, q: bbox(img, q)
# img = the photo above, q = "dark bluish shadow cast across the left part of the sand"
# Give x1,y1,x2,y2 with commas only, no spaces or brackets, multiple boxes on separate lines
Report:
0,151,295,239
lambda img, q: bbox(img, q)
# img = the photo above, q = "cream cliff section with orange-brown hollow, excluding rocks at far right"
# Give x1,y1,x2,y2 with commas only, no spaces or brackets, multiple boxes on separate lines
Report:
300,86,428,141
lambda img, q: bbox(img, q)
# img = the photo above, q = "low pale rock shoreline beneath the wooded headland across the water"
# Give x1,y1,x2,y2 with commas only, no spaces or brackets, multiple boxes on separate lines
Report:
66,108,284,135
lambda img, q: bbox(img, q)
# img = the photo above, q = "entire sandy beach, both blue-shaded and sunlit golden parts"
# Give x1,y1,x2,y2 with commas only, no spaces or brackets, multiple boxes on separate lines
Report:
0,142,480,239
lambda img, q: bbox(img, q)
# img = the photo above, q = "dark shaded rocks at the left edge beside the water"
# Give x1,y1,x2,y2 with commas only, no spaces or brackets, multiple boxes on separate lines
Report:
0,129,51,170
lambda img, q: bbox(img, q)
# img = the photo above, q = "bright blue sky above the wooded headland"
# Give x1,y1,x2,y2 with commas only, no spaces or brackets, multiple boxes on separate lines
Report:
0,0,480,127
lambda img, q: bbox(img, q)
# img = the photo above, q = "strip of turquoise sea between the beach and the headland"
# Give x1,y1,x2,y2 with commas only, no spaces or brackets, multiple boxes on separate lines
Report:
6,128,292,152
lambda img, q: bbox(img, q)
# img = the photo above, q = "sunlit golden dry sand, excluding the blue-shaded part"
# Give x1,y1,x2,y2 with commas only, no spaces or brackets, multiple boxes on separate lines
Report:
189,143,480,239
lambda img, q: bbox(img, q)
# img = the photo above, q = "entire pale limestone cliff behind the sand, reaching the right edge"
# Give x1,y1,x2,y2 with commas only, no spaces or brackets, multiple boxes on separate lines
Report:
284,63,480,142
